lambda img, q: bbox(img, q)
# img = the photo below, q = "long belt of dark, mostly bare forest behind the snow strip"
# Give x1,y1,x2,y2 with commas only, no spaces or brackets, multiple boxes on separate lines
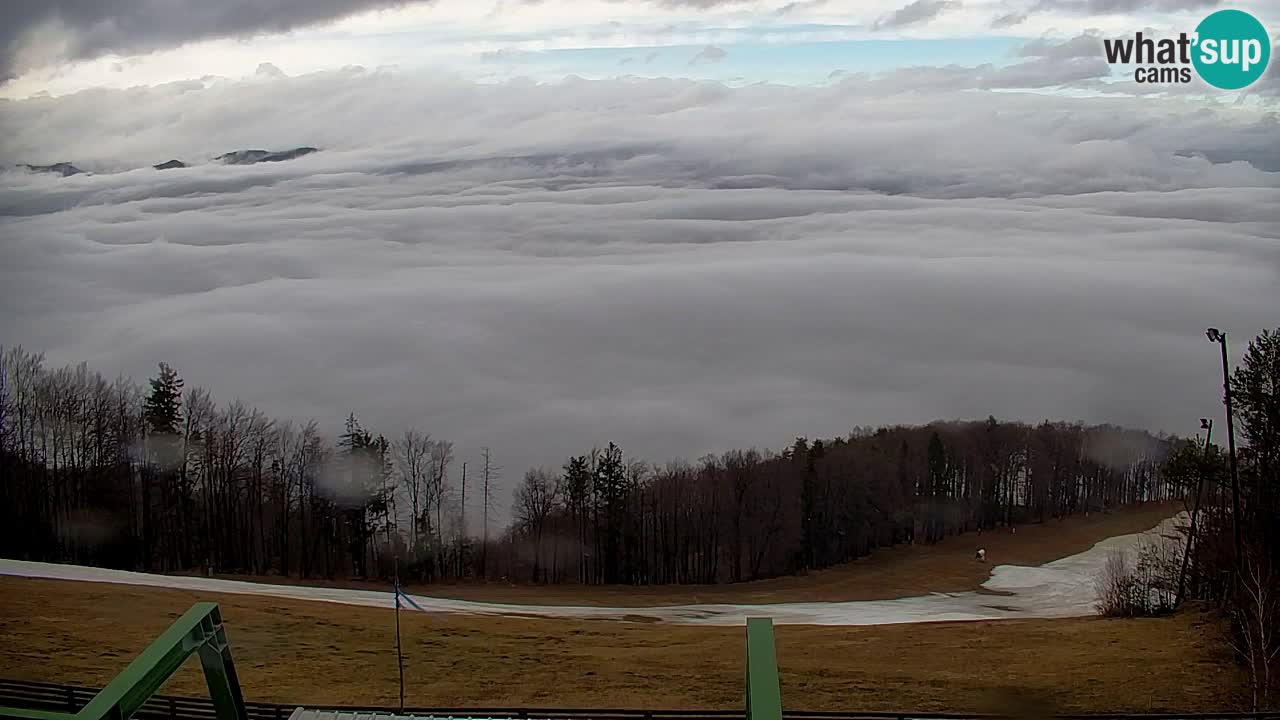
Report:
0,347,1185,584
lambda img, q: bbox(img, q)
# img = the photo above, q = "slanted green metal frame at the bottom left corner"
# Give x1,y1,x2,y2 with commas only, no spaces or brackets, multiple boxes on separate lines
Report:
0,602,248,720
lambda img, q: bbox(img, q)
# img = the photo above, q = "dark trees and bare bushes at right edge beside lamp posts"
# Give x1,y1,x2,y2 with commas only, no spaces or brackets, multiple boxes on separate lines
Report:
1098,329,1280,710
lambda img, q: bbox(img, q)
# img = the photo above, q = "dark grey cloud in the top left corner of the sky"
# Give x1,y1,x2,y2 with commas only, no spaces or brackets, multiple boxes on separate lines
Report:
0,0,429,82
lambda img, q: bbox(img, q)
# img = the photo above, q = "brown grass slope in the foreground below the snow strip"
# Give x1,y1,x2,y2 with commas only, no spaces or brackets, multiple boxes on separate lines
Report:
0,502,1239,712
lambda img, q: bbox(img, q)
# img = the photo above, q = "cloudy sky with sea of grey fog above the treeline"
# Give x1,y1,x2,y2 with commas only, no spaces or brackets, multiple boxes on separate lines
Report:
0,0,1280,504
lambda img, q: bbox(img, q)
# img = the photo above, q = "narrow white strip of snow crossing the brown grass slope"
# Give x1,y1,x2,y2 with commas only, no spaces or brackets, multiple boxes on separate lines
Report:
0,514,1185,625
